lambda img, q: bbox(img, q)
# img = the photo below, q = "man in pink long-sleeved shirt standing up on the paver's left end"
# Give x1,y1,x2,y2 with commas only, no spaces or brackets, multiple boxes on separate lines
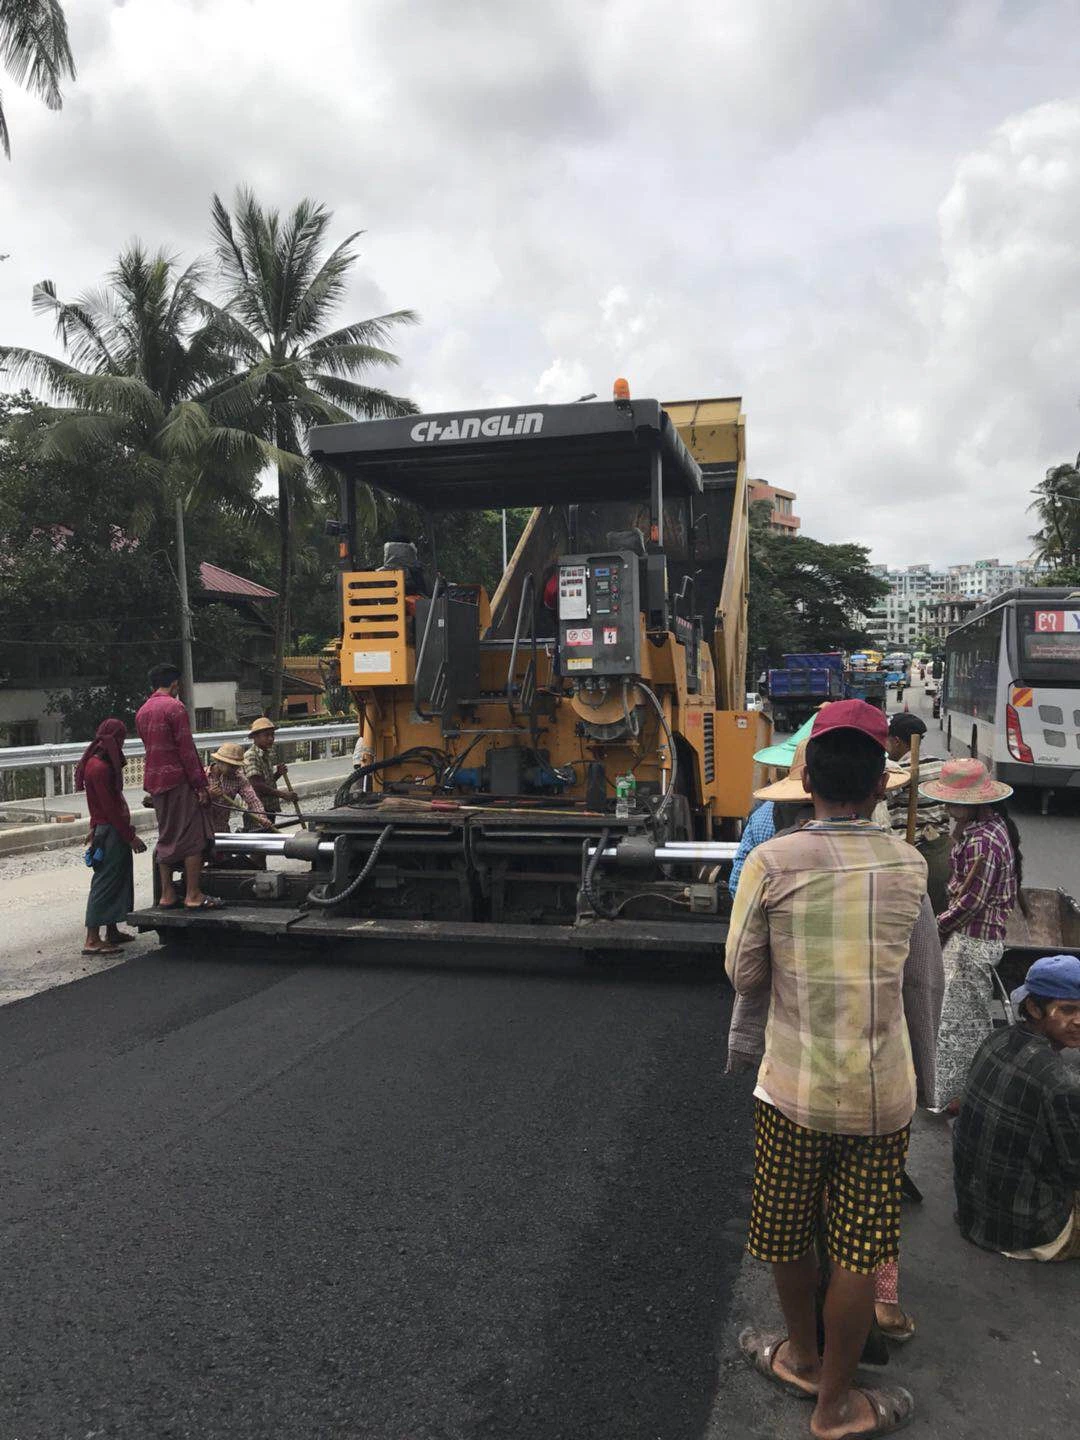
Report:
135,665,220,910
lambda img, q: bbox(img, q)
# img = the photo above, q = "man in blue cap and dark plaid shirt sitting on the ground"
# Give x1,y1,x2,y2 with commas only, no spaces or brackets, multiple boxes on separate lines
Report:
953,955,1080,1260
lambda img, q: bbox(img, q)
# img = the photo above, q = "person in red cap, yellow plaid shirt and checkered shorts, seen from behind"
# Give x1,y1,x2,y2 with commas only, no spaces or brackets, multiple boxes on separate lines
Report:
726,700,942,1437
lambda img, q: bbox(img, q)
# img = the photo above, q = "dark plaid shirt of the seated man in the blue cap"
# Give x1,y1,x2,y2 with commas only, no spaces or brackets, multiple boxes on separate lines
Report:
953,1024,1080,1251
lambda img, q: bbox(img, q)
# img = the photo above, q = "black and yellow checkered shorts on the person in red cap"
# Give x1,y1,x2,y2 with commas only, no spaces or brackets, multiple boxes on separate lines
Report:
746,1099,910,1274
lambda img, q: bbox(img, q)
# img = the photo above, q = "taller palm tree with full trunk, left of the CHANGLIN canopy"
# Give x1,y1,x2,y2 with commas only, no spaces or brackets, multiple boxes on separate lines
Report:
203,187,416,716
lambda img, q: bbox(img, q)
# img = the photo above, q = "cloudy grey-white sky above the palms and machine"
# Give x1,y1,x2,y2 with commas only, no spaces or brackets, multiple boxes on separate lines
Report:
0,0,1080,564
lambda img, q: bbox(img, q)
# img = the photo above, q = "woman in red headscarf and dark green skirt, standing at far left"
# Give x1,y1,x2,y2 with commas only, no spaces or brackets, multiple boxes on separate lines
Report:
75,720,147,955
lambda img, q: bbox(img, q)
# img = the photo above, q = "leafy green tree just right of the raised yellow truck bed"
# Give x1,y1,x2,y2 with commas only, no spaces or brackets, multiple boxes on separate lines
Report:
747,501,888,681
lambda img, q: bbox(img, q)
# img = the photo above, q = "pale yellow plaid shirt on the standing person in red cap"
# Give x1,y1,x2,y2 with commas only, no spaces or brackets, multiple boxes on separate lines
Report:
726,821,943,1135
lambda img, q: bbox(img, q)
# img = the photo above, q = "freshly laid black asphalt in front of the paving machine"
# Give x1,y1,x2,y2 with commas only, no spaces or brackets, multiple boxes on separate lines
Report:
0,946,750,1440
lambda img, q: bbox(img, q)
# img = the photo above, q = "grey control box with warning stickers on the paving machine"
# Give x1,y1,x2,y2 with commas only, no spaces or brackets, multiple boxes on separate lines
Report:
559,552,641,678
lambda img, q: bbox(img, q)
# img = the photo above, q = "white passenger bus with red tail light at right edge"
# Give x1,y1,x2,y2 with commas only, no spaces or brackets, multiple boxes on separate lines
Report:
940,588,1080,809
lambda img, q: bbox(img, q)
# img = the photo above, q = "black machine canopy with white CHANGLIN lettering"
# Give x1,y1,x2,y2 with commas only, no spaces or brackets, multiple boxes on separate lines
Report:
308,400,703,510
